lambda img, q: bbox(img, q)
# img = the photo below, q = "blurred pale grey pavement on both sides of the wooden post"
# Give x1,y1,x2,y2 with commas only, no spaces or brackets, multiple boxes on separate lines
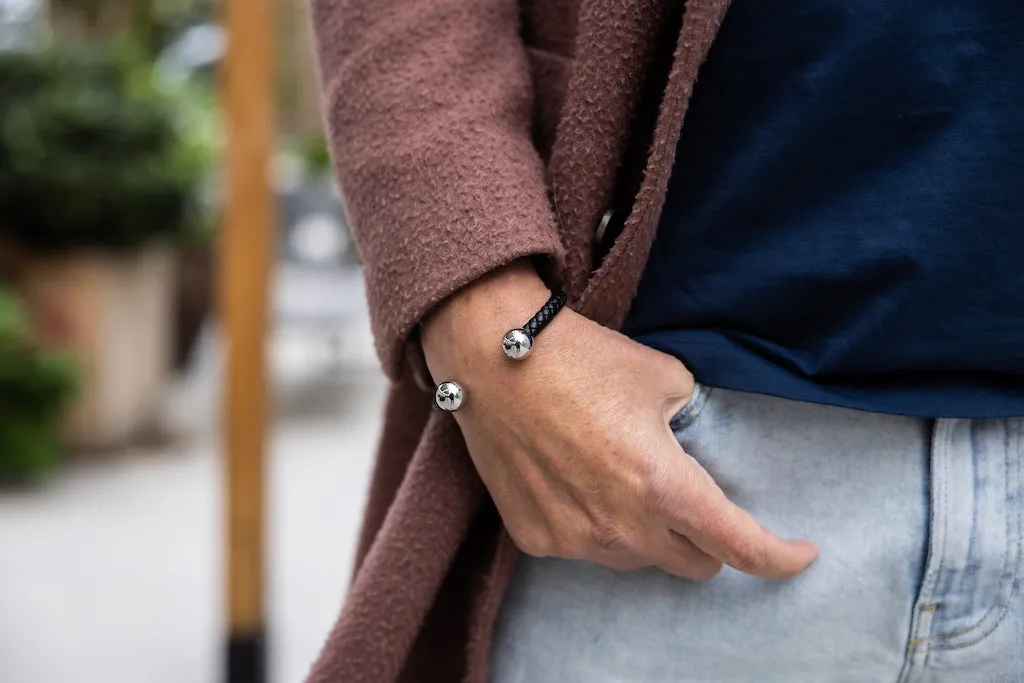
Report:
0,327,384,683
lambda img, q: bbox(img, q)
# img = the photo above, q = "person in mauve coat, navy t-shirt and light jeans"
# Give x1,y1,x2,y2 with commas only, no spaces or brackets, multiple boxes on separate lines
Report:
309,0,1024,683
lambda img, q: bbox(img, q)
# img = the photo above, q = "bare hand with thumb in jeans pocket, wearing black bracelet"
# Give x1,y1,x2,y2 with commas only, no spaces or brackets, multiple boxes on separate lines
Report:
422,263,817,579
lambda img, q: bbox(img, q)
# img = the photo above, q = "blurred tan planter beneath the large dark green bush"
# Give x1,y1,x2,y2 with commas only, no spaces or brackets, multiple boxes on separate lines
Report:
6,242,175,450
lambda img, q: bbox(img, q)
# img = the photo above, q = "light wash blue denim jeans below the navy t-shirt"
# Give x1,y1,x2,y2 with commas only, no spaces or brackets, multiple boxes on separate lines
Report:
490,388,1024,683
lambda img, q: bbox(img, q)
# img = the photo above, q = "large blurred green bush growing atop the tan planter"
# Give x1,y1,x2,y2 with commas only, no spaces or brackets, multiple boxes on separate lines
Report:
0,42,212,251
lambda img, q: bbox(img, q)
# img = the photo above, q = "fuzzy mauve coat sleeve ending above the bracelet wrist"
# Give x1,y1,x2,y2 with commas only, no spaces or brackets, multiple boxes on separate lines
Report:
311,0,562,379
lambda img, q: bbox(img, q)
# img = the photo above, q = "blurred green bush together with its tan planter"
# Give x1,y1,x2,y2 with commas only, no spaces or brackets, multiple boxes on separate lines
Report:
0,42,209,447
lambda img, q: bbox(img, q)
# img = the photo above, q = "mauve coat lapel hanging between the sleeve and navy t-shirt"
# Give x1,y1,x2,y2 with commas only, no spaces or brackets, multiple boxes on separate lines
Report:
549,0,729,321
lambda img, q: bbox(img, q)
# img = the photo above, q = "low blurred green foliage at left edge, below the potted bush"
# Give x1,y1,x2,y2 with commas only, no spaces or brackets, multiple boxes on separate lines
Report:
0,284,78,481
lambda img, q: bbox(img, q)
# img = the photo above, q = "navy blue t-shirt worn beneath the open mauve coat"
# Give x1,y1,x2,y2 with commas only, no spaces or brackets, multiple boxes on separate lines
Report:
626,0,1024,418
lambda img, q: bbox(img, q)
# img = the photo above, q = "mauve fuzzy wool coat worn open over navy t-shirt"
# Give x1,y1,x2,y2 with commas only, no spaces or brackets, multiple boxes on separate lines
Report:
308,0,728,683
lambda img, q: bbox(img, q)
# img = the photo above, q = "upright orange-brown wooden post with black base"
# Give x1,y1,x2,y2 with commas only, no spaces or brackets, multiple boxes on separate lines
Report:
220,0,274,683
